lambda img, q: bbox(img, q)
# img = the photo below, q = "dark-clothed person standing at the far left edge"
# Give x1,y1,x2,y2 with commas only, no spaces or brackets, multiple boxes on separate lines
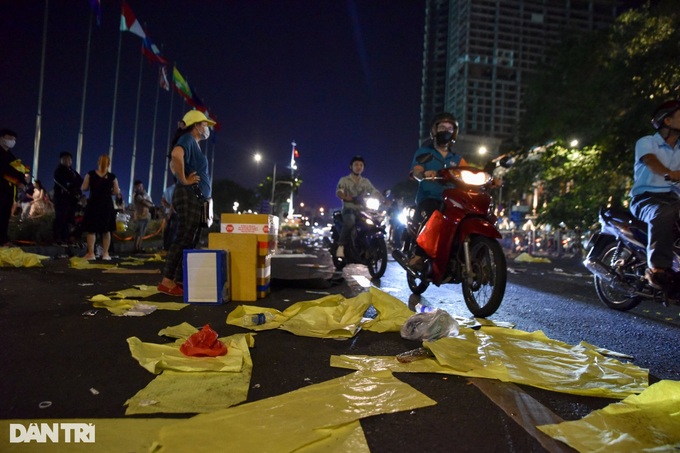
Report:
0,129,24,247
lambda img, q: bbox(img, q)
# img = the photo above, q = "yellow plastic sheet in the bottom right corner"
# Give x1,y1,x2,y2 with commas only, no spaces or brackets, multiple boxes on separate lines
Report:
538,381,680,453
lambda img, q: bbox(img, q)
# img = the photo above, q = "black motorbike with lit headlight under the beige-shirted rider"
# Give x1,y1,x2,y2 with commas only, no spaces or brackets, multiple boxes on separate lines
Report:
324,198,387,278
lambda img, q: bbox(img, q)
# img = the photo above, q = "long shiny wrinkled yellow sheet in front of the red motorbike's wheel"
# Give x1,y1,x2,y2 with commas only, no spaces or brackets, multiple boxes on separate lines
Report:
331,327,648,398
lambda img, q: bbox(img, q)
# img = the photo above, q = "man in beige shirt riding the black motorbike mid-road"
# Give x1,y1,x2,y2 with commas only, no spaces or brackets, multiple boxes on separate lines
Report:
335,156,384,258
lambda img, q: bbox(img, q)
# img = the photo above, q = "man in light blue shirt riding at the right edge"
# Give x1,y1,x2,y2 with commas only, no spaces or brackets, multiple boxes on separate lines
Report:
630,100,680,289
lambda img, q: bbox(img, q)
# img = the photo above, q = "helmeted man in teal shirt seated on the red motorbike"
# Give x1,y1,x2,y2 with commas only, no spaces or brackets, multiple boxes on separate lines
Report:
408,112,468,272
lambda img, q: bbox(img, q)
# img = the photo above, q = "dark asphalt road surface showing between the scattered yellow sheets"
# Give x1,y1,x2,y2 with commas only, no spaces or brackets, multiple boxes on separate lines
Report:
0,237,680,453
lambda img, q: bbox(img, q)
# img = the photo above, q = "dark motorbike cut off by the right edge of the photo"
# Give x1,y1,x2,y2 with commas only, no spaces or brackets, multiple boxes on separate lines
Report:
583,204,680,311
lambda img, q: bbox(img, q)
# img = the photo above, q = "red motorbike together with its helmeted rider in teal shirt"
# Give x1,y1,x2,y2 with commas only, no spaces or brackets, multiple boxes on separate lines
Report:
392,113,507,317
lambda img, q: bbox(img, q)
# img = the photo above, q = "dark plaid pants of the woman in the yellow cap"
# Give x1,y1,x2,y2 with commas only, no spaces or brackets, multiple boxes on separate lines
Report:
163,184,203,282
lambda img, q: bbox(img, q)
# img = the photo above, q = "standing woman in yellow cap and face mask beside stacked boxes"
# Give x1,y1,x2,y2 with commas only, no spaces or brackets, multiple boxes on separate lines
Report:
158,110,215,296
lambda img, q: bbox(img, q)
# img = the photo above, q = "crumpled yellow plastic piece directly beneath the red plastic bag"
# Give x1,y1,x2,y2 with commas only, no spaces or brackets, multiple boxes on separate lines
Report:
127,337,247,374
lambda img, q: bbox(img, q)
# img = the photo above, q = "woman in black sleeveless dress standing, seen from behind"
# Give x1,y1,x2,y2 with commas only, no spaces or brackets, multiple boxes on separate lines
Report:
81,154,123,261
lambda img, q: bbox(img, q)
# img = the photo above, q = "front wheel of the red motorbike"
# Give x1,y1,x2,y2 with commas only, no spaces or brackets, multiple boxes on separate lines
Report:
462,236,508,318
